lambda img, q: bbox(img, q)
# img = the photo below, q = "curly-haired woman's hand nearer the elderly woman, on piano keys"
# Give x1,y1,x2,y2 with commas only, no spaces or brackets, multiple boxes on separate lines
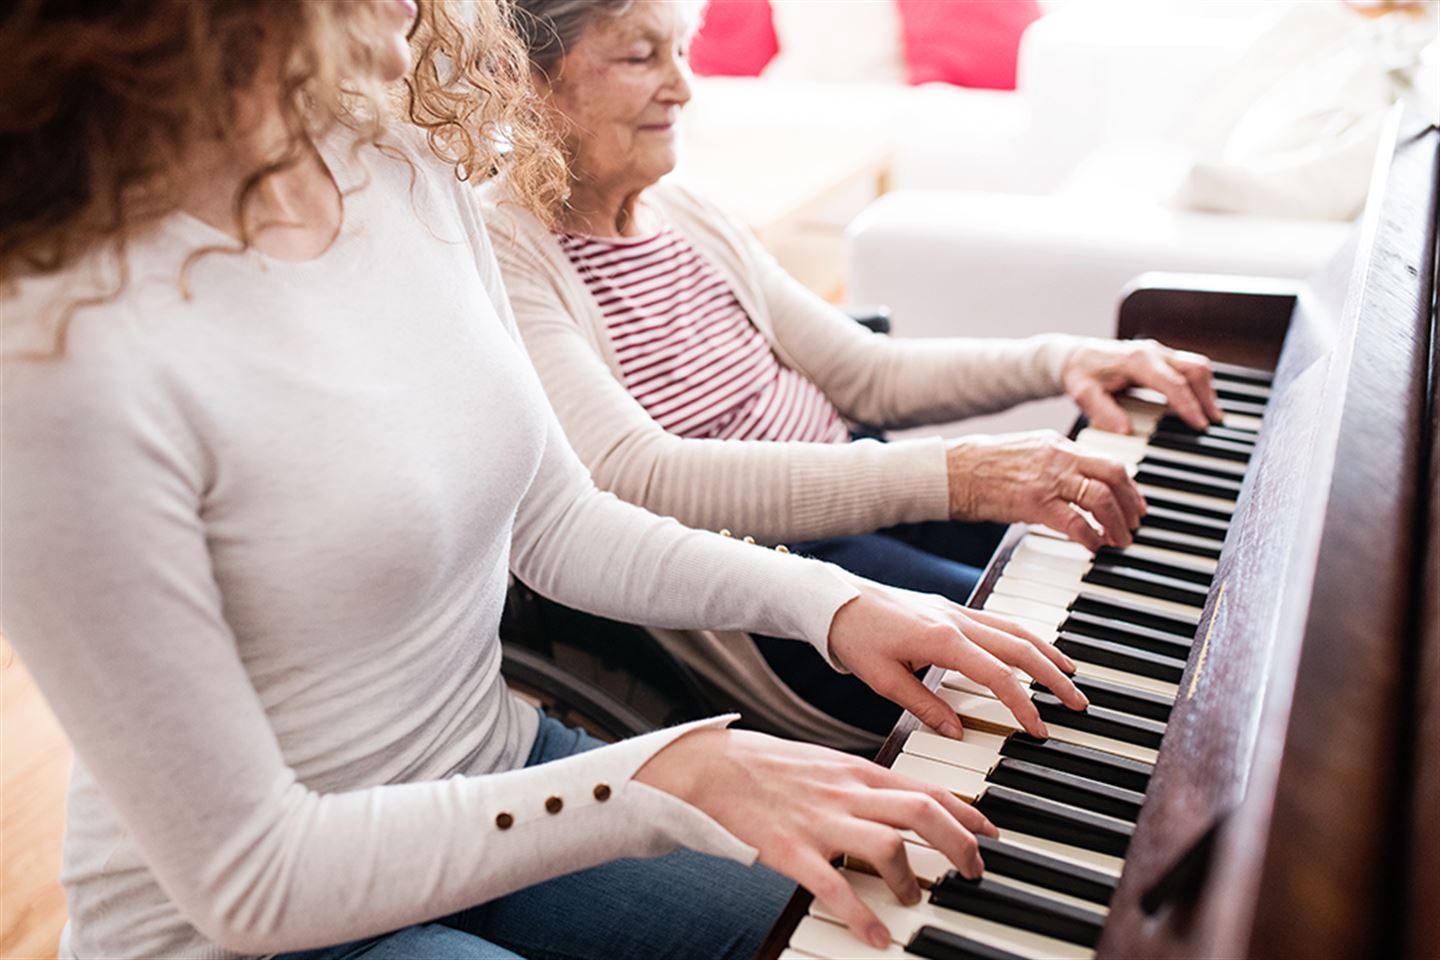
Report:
829,577,1089,737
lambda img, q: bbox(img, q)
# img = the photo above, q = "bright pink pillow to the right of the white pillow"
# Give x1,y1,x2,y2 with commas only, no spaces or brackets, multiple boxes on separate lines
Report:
896,0,1043,91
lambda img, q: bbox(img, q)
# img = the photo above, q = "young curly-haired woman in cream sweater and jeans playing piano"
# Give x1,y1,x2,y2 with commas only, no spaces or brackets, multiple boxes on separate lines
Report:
0,0,1084,959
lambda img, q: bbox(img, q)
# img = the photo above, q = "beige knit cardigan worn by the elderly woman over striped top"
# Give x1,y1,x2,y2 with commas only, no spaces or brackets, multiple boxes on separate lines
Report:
481,178,1079,543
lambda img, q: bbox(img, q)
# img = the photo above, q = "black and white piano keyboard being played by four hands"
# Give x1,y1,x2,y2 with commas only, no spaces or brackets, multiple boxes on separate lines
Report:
780,364,1270,960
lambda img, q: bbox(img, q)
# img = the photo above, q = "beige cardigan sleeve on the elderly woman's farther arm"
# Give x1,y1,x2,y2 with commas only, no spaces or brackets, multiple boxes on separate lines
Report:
679,184,1084,427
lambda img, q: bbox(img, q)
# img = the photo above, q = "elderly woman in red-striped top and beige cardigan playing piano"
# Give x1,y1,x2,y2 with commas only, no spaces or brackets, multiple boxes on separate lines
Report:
485,0,1220,731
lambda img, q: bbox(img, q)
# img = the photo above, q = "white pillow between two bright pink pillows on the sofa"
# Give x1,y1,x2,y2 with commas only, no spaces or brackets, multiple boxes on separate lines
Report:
762,0,906,83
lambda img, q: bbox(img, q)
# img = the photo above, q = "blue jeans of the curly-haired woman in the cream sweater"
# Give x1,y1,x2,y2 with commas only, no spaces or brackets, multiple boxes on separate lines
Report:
278,717,795,960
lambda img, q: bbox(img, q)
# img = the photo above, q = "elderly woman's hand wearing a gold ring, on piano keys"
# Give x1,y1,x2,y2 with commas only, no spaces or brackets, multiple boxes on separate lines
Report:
946,431,1145,550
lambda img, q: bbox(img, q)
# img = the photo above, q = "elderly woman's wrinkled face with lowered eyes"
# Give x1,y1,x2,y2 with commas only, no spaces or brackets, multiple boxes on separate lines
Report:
550,1,690,189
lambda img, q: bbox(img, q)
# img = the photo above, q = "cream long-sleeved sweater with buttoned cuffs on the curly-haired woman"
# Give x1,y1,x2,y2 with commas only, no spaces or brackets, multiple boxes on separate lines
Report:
3,133,855,957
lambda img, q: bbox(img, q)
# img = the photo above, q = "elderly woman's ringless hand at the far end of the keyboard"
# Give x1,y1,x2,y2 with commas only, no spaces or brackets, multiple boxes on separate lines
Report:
1060,340,1221,433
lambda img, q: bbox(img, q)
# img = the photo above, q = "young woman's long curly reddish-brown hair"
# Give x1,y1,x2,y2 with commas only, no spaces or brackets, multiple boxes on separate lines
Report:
0,0,564,347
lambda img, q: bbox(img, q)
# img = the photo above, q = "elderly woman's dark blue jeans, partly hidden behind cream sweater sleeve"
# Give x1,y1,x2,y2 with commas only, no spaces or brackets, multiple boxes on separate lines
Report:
755,521,1005,734
